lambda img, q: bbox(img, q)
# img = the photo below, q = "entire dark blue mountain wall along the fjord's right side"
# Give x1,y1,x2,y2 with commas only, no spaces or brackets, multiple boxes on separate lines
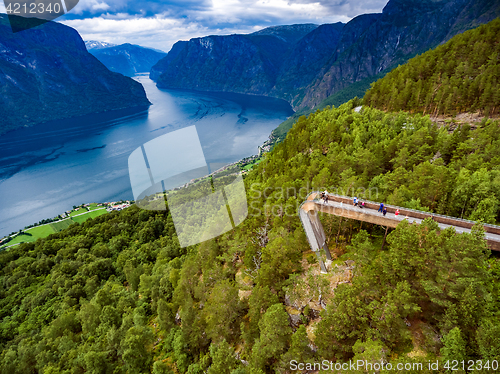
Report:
151,0,500,109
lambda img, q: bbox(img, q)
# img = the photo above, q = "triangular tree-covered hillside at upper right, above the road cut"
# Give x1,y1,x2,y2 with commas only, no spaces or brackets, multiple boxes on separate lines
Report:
364,18,500,115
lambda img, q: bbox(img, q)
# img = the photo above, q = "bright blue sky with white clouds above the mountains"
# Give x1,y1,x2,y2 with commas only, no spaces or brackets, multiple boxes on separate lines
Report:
0,0,388,52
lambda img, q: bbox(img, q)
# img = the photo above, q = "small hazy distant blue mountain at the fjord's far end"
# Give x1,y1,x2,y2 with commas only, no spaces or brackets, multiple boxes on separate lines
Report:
89,43,167,77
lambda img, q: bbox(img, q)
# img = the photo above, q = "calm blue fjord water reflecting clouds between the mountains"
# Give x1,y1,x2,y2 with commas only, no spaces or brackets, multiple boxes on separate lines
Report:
0,75,293,237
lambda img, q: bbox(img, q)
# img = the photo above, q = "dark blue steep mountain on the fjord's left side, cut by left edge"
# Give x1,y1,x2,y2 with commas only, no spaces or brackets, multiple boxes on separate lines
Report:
0,15,150,133
